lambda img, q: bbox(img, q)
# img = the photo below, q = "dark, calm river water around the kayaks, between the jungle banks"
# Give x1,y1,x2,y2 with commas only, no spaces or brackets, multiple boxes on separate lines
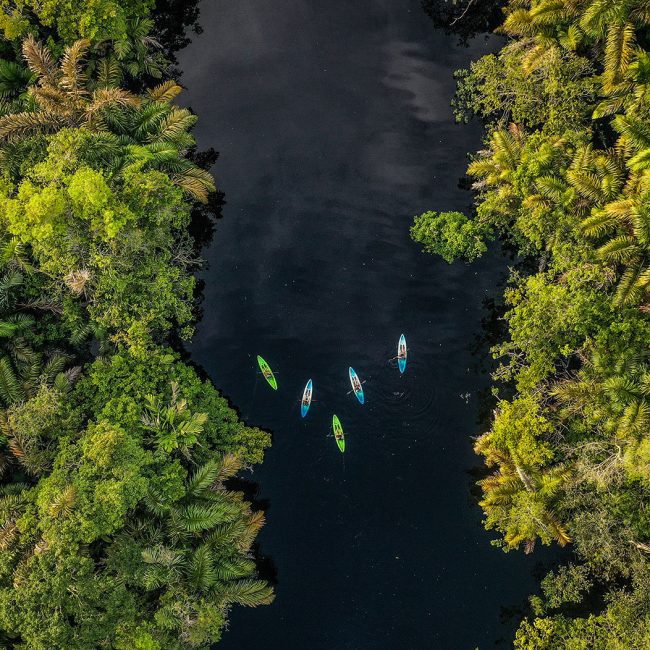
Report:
180,0,552,650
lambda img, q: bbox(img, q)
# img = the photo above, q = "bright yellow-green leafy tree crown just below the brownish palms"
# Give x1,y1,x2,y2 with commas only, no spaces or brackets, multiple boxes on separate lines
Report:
0,129,194,345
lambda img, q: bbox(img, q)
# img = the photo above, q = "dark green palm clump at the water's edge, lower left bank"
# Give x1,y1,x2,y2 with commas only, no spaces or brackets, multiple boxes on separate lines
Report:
134,455,273,636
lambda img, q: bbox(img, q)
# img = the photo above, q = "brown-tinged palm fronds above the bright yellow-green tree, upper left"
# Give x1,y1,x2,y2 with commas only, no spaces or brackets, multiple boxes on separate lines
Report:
0,36,215,203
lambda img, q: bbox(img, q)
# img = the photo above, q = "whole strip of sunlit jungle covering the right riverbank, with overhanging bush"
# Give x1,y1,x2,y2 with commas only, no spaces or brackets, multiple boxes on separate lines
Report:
412,0,650,650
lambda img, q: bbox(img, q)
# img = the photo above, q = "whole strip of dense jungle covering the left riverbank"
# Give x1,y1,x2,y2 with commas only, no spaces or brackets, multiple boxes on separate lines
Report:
0,7,273,650
